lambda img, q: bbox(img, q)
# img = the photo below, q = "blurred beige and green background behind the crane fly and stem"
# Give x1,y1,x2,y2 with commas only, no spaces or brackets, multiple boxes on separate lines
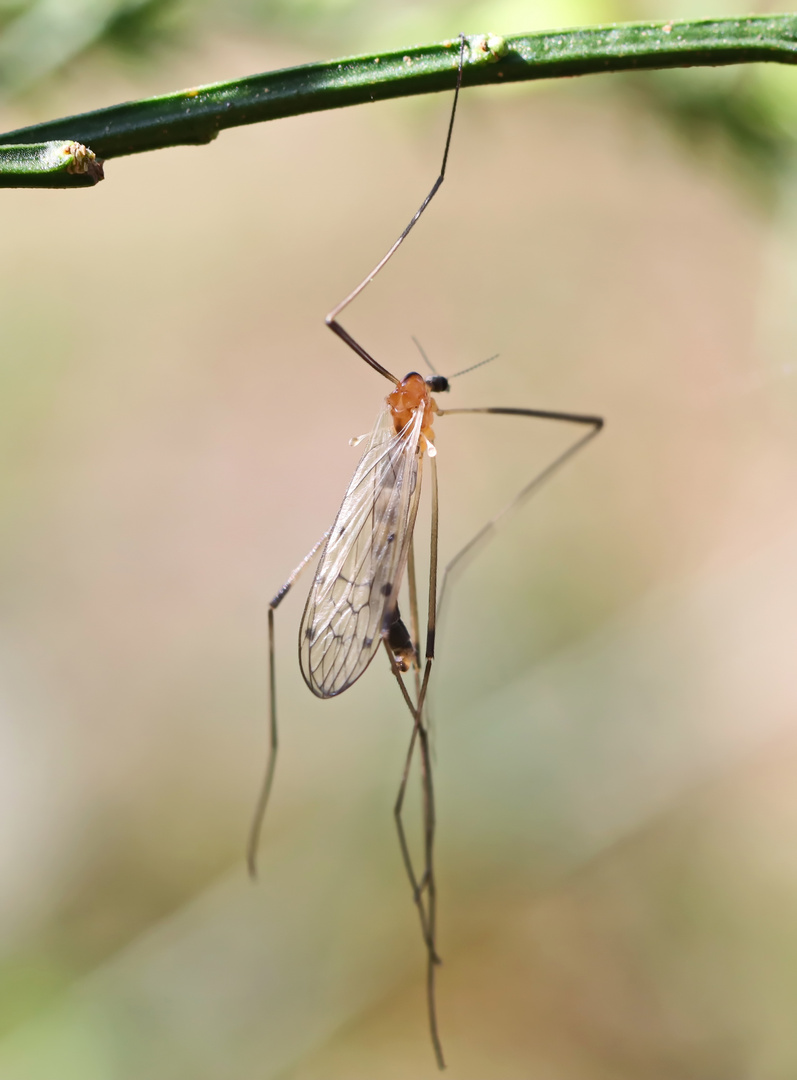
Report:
0,0,797,1080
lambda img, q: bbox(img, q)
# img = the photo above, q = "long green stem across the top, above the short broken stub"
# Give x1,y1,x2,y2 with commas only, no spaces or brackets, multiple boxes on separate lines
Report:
0,14,797,185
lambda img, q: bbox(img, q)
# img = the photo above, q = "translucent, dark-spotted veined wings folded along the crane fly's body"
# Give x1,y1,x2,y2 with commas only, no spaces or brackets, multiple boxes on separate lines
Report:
299,405,423,698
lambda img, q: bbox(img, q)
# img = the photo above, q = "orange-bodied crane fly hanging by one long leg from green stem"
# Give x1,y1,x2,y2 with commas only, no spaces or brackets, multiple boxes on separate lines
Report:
247,35,604,1068
